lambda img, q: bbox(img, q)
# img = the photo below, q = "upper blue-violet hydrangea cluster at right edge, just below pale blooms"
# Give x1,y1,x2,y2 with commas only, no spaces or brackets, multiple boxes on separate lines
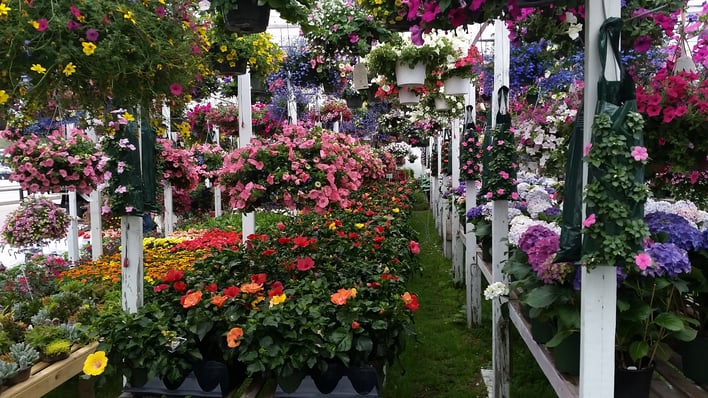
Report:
644,211,705,251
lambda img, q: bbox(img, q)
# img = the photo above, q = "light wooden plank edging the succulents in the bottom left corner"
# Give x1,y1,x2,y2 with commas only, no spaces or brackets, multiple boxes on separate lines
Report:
2,342,98,398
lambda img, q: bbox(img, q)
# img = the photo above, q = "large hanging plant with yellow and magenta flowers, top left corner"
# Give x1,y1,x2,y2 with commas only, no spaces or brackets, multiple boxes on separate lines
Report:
0,0,201,115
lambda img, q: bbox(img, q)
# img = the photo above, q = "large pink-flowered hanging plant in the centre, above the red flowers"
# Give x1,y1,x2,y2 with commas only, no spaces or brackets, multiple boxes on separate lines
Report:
218,125,384,213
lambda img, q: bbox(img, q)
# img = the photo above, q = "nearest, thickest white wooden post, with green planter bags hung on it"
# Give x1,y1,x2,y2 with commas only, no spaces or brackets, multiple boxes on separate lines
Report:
579,0,621,398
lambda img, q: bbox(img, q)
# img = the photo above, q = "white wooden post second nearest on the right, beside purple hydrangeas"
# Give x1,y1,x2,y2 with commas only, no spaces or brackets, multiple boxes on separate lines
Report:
492,20,511,398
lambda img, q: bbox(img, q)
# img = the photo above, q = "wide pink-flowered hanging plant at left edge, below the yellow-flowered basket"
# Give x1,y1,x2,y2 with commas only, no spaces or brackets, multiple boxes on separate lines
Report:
2,129,108,194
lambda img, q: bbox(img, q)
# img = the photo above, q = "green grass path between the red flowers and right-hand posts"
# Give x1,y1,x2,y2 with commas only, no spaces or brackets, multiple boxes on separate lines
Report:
382,211,555,398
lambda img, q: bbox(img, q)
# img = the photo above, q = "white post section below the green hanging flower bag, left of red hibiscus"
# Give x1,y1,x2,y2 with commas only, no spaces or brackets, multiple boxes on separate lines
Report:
120,216,143,313
